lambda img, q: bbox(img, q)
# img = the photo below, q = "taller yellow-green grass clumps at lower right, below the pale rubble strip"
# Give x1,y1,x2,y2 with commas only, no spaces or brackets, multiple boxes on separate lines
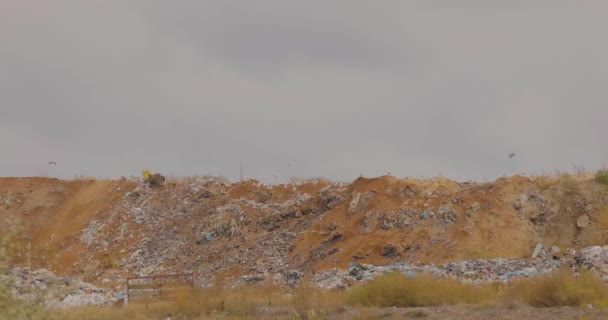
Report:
345,271,608,308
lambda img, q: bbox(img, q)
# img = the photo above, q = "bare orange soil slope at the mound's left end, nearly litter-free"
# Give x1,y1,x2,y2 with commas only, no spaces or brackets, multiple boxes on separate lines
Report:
0,178,134,274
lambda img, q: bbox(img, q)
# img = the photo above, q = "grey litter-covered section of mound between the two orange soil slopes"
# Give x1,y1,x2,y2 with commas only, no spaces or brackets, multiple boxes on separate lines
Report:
74,175,340,285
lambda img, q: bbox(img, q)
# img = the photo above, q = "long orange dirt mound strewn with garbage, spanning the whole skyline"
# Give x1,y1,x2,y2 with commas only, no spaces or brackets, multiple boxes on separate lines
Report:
0,175,608,283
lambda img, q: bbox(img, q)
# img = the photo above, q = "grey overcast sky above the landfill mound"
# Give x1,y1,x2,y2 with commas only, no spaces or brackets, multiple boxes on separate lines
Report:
0,0,608,182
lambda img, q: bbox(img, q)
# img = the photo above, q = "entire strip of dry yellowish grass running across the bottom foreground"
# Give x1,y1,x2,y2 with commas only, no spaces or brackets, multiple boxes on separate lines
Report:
0,272,608,320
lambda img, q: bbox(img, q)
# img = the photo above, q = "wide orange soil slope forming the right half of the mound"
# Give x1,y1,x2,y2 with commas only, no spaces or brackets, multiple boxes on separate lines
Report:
293,176,608,269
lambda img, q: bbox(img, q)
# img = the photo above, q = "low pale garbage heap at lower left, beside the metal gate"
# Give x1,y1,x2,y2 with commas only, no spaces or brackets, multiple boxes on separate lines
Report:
0,268,120,308
